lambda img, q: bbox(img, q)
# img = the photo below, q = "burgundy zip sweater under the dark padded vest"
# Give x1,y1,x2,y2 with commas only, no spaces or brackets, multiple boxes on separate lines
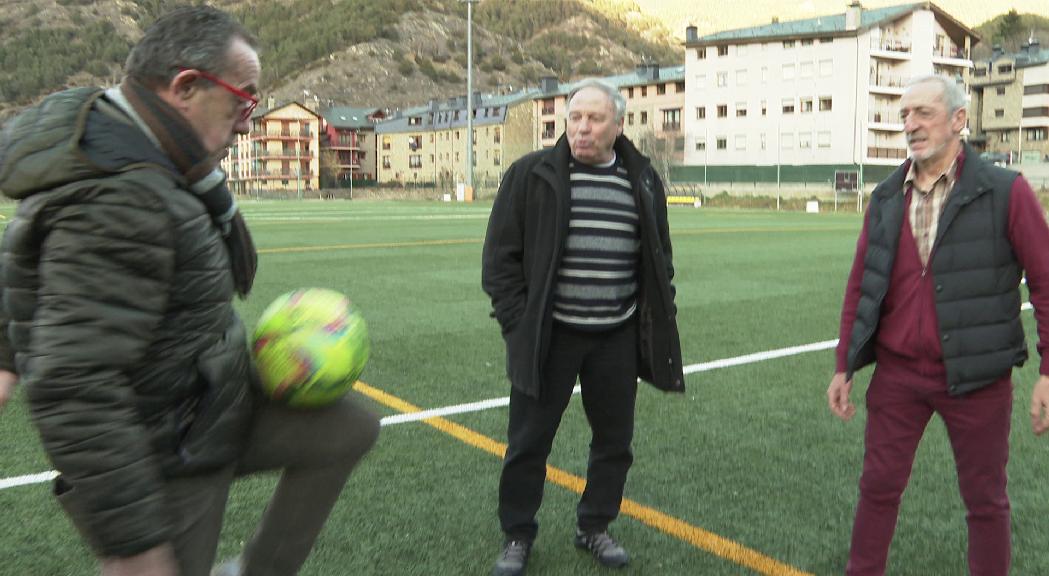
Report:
835,168,1049,378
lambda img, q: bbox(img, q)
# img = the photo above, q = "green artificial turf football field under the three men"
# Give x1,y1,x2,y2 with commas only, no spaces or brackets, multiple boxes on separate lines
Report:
0,200,1049,576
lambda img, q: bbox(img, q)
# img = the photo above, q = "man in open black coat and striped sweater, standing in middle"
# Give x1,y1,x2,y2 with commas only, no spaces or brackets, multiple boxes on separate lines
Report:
481,80,684,576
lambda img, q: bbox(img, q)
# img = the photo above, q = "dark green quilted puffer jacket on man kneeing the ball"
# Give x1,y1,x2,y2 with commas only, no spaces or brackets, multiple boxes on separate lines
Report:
0,88,254,556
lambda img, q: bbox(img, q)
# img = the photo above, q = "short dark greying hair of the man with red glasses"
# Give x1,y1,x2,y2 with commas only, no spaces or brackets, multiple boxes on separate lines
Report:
124,6,258,88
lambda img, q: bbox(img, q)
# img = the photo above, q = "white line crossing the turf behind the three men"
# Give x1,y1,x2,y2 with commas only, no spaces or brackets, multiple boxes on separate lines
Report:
0,302,1031,490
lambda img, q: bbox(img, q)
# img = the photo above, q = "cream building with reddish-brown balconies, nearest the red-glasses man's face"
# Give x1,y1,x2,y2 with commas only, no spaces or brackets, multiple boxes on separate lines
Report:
222,102,322,197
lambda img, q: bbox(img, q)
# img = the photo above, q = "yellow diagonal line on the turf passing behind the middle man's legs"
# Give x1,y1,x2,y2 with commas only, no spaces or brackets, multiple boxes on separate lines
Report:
354,382,812,576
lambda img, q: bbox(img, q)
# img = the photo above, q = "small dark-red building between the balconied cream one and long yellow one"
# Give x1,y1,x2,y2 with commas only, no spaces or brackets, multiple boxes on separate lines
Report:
321,106,386,186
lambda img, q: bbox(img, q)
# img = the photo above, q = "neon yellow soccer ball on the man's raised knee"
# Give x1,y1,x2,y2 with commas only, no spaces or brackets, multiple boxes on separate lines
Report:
252,289,371,407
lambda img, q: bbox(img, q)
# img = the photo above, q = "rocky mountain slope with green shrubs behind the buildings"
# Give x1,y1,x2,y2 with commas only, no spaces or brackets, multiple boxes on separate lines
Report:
0,0,683,122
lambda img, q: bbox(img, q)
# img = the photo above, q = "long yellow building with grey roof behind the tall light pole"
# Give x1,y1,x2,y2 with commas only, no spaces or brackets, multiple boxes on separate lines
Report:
376,90,535,188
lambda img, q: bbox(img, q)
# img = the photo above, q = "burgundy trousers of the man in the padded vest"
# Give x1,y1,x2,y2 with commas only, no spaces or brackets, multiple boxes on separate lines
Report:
845,364,1012,576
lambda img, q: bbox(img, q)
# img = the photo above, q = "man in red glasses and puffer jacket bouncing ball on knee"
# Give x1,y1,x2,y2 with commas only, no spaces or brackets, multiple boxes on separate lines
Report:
0,6,379,576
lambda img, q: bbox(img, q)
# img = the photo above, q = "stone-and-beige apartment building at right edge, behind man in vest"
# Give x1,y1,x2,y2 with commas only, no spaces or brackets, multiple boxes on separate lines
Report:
969,39,1049,163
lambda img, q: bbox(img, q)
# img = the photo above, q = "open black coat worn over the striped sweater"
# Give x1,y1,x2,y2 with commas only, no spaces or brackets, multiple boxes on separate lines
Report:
481,135,685,398
